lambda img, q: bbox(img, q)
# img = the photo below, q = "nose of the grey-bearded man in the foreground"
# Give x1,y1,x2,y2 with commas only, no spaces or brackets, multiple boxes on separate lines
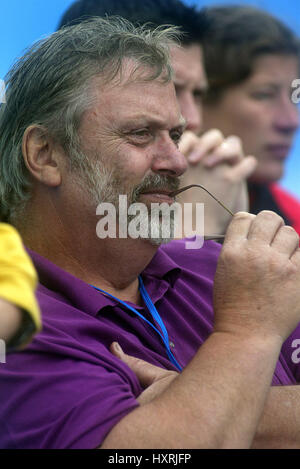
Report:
151,136,188,177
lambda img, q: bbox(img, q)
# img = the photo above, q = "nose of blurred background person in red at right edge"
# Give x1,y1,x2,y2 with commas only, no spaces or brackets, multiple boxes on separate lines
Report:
274,96,299,134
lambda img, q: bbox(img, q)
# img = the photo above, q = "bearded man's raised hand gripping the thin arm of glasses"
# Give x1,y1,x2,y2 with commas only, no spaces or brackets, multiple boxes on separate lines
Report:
214,211,300,340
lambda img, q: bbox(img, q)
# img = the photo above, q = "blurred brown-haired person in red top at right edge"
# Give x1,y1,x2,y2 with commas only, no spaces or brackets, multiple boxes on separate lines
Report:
202,6,300,233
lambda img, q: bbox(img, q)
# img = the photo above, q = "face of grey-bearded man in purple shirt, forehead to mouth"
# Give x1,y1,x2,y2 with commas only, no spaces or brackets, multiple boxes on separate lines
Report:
72,61,187,241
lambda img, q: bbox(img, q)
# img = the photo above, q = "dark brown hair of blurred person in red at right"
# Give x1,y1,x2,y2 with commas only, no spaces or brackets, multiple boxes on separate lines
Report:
203,6,300,104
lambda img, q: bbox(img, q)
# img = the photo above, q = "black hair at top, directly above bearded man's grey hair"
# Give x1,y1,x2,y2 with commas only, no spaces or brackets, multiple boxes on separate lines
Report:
58,0,208,45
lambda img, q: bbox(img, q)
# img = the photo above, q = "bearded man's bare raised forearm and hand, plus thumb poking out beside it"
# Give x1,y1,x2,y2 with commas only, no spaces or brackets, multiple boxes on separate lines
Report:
102,212,300,449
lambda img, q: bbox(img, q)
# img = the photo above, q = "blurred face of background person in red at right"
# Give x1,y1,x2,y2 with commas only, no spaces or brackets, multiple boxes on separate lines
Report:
204,54,299,182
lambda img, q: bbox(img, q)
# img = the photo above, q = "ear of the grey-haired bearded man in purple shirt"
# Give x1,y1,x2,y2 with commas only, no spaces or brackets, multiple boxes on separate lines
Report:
22,125,62,187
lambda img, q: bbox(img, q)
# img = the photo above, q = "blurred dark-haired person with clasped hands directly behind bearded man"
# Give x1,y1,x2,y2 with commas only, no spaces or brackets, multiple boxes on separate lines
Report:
59,0,256,236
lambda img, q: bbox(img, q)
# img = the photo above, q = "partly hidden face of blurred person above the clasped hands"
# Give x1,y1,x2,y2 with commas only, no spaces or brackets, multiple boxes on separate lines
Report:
171,44,207,133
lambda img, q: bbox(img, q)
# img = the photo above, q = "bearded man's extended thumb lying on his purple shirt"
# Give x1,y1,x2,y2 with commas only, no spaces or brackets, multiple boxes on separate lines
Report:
110,342,166,387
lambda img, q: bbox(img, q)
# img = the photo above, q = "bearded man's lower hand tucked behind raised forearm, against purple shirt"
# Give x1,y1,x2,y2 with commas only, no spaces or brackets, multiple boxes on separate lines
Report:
110,342,178,405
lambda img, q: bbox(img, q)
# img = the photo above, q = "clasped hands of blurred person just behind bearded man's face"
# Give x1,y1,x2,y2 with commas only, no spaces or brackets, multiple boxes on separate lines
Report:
178,130,257,236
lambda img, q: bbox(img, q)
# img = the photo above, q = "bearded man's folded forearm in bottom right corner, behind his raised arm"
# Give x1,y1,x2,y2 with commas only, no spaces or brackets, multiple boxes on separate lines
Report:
252,386,300,449
